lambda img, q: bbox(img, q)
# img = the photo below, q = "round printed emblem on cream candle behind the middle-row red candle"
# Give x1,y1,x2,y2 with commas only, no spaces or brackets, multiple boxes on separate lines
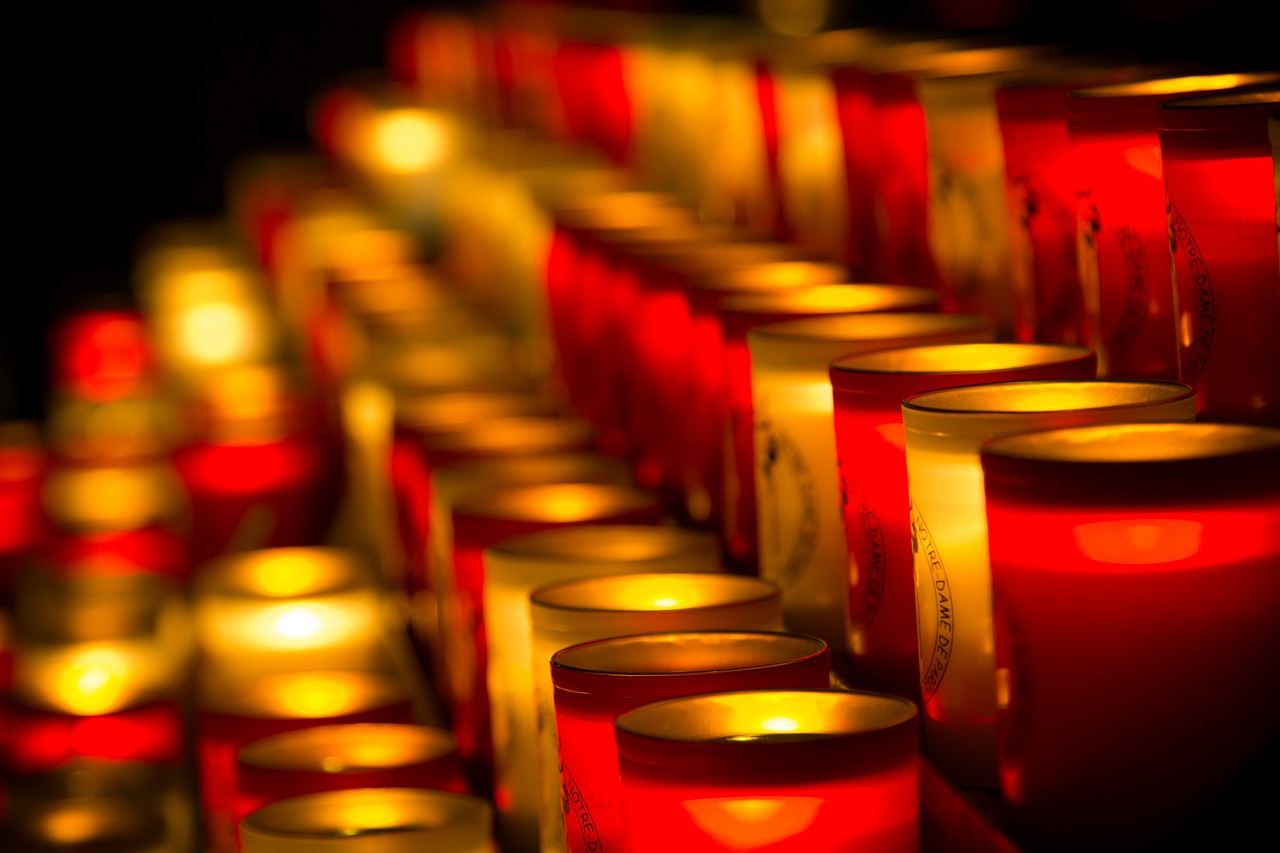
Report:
756,418,818,585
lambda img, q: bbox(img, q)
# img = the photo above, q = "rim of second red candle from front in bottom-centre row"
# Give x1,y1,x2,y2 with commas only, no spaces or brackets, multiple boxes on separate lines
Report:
550,629,829,680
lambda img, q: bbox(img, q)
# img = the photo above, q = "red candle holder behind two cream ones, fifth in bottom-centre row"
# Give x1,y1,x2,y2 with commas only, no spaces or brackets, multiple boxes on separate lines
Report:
443,483,666,792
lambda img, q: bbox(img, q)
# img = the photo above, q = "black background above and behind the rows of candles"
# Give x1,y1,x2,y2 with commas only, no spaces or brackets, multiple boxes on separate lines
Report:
0,0,1280,419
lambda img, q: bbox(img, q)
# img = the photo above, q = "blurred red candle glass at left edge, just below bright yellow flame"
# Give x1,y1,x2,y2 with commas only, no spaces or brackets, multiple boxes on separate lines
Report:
4,702,184,775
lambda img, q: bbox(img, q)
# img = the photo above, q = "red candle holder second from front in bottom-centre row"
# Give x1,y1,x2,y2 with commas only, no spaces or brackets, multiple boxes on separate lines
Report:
552,631,831,853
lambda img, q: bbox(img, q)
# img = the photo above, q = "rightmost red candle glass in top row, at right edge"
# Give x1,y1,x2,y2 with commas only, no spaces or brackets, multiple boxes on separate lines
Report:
1158,88,1280,427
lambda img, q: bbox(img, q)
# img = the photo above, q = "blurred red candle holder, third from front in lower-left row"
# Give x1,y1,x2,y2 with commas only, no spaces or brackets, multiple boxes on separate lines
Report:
196,670,413,853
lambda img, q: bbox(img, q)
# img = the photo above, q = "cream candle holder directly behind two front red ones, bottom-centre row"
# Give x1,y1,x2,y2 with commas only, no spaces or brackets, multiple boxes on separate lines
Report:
529,573,782,849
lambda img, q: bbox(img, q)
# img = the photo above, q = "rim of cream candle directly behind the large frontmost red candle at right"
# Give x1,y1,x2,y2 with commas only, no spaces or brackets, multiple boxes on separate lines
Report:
902,379,1196,418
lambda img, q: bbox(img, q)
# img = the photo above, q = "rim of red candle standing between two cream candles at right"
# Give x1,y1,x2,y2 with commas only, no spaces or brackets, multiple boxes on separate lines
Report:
831,342,1096,376
